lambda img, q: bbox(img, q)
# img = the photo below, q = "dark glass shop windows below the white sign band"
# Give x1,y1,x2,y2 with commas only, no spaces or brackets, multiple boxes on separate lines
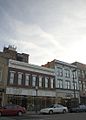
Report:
7,95,55,111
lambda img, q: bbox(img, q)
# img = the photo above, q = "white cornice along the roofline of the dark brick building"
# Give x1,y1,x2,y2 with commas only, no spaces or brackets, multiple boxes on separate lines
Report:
9,60,55,75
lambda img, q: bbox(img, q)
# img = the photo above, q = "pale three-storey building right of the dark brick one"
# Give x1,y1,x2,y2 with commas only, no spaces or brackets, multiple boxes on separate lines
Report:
43,59,80,104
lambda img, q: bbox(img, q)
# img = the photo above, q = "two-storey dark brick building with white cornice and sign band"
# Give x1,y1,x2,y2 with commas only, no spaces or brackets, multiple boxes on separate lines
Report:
6,60,56,110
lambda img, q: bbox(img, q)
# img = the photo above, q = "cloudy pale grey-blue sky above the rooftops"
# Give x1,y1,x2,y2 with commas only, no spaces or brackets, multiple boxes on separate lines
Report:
0,0,86,65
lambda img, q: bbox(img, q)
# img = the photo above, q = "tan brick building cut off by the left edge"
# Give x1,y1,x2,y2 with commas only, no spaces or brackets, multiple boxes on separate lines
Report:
0,57,8,106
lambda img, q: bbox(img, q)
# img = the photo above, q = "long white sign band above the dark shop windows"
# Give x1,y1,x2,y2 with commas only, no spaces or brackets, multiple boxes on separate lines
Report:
6,87,56,97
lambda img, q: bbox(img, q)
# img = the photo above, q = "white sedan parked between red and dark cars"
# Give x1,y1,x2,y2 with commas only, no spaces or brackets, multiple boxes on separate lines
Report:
40,104,68,114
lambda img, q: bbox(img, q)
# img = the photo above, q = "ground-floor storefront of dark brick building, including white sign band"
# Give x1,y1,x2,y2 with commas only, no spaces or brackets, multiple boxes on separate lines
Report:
6,87,56,111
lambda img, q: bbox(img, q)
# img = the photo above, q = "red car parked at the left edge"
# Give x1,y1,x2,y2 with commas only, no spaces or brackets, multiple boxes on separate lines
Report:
0,104,26,116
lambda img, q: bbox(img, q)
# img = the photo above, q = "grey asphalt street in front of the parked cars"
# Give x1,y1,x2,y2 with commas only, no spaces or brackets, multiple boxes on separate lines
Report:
0,113,86,120
